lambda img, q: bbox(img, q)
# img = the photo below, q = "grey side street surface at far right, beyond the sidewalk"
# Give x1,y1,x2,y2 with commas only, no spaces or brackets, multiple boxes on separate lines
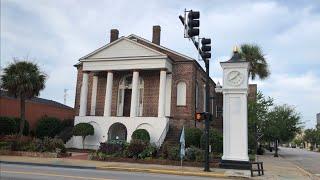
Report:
279,147,320,176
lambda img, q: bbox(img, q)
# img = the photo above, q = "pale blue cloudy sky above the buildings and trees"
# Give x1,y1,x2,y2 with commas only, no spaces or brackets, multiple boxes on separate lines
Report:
0,0,320,128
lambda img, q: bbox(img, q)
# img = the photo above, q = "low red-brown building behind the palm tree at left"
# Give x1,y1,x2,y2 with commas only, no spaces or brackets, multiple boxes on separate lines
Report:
0,90,74,130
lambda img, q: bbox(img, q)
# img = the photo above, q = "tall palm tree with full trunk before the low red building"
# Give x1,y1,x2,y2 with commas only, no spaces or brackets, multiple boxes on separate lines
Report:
1,60,47,135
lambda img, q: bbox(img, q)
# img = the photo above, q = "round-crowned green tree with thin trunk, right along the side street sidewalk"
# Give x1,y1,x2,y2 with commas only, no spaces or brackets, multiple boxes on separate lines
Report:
262,104,301,157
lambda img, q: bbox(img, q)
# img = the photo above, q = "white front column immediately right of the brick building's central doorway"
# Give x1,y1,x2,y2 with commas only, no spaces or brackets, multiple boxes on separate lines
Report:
130,71,139,117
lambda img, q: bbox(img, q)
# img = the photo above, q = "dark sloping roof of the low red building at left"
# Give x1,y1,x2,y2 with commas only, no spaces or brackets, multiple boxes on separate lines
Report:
0,90,73,109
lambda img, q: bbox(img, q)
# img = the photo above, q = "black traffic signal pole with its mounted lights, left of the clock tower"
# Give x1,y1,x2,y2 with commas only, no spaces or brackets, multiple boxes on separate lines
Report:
179,10,212,172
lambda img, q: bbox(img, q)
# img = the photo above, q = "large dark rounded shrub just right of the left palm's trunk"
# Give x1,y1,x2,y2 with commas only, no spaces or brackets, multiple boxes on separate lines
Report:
36,116,61,138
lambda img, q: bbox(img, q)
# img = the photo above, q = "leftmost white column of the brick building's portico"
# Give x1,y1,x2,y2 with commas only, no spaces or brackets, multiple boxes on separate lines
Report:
79,72,89,116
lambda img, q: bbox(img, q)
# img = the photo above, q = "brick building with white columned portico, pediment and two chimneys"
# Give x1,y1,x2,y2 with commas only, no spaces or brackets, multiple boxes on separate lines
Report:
69,26,255,148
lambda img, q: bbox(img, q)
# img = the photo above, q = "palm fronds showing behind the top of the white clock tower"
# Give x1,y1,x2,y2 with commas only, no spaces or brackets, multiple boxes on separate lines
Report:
240,44,270,80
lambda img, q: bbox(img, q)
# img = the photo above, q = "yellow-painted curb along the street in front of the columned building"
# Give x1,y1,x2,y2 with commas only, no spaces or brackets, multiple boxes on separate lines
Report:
97,166,230,178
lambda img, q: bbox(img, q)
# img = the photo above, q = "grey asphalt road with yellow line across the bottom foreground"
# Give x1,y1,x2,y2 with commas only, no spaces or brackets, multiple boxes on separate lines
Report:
0,163,228,180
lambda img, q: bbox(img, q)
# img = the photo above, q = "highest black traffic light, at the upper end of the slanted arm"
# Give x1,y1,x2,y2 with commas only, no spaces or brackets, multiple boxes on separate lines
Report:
187,10,200,37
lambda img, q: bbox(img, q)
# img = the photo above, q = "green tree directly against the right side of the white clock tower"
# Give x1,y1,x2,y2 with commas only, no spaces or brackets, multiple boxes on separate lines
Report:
248,91,273,153
